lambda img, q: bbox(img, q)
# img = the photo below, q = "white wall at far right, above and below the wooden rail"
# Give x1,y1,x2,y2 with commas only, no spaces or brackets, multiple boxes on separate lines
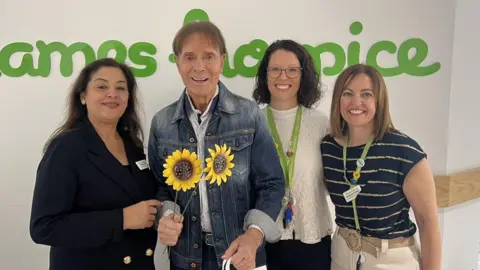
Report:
440,0,480,270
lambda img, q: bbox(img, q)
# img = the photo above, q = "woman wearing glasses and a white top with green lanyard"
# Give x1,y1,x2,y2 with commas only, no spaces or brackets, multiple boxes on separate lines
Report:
253,40,332,270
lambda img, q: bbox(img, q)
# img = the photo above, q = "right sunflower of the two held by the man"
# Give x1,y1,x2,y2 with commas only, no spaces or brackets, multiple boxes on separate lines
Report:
204,144,235,186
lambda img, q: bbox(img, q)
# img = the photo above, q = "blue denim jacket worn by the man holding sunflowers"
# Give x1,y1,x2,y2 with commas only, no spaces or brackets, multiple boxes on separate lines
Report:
148,82,285,269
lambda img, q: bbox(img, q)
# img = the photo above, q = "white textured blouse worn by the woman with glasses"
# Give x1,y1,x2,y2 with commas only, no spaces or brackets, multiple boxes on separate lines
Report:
263,107,333,244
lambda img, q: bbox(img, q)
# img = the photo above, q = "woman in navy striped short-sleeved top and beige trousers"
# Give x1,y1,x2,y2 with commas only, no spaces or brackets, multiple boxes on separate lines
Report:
321,64,441,270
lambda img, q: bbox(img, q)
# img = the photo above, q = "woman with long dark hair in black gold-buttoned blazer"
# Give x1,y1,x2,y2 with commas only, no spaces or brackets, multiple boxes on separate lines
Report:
30,59,160,270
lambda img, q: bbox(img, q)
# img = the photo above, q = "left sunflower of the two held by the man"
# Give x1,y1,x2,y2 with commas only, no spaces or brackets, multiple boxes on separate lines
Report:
163,149,202,192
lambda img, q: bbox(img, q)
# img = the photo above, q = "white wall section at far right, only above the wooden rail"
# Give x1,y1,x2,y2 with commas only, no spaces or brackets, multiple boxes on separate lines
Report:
447,0,480,173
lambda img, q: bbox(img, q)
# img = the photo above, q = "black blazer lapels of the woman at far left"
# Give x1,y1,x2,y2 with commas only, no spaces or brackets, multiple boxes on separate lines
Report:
82,120,141,202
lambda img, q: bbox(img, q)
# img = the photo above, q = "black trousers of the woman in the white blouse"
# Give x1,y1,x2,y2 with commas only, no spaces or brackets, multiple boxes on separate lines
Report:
265,236,332,270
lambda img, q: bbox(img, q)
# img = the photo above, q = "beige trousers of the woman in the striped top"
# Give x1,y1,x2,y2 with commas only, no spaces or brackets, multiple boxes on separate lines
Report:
331,229,420,270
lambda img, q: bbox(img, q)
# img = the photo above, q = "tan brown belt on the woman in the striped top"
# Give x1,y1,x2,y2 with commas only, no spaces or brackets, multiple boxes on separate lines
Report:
338,227,415,258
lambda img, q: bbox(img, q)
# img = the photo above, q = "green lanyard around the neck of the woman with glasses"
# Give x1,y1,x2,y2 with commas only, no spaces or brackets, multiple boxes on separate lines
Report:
267,106,302,188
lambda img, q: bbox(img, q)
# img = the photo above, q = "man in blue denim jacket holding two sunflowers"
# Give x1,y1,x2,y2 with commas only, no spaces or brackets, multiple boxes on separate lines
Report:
148,21,285,270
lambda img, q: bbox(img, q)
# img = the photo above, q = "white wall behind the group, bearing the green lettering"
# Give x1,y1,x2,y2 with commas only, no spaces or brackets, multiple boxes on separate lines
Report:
0,0,472,270
